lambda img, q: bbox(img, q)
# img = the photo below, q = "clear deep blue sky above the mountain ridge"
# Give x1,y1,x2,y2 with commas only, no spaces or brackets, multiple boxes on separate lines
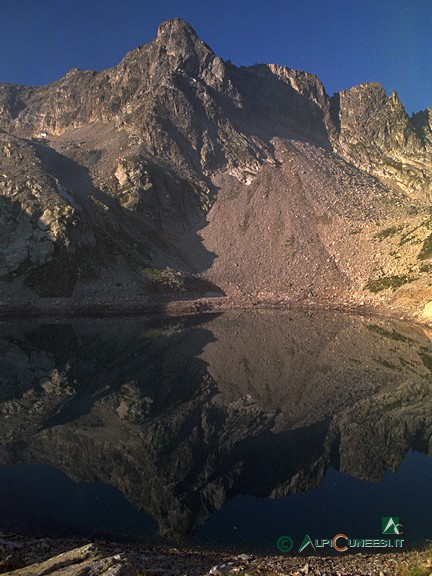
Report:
0,0,432,113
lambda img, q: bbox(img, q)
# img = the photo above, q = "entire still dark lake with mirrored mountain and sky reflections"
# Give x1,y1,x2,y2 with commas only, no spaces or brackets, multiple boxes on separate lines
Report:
0,311,432,553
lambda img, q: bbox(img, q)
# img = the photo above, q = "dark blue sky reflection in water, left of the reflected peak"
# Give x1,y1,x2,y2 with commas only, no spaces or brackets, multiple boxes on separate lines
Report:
0,464,157,538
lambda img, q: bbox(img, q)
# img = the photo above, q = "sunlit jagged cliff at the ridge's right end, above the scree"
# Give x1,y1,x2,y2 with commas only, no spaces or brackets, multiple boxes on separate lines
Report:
333,83,432,202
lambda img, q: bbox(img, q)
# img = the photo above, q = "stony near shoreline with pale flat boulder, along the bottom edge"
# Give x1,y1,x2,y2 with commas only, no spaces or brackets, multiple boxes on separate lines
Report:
0,533,432,576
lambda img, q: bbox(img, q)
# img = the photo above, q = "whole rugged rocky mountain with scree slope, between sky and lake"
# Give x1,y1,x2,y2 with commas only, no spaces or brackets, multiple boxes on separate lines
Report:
0,19,432,321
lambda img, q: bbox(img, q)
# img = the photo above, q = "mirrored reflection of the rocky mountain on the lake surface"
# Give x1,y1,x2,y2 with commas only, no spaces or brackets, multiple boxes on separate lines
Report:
0,311,432,539
